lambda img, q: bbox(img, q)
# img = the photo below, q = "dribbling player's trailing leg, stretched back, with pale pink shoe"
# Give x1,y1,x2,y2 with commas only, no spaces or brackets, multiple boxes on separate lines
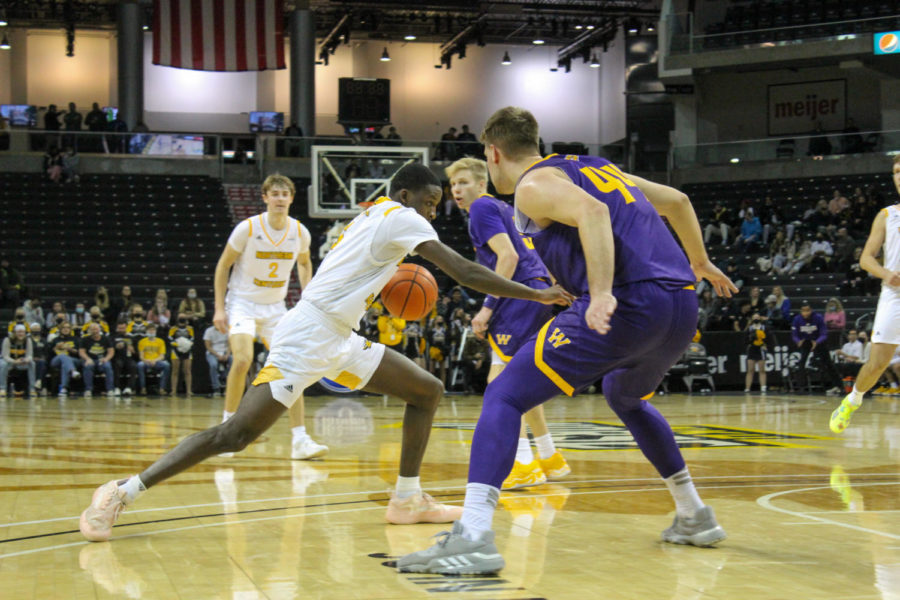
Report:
80,383,287,541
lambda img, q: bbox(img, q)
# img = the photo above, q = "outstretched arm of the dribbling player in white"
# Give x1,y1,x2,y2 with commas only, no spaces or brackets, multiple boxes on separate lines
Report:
416,240,573,305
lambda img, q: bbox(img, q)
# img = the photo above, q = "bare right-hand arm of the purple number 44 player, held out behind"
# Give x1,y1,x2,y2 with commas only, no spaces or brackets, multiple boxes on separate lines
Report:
628,174,738,298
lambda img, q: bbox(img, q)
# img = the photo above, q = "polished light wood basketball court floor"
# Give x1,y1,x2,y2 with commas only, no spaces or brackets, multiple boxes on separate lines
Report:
0,394,900,600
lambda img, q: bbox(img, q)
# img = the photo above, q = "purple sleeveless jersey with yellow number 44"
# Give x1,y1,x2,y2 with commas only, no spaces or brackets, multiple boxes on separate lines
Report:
515,154,696,296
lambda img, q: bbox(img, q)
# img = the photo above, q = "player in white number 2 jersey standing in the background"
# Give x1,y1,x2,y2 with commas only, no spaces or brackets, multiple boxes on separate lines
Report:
213,174,328,460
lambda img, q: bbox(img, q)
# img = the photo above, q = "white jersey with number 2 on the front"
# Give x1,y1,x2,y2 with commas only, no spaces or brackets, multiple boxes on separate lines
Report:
228,213,310,304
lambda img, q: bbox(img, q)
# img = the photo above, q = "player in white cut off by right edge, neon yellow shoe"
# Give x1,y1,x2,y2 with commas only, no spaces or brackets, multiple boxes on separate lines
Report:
828,156,900,433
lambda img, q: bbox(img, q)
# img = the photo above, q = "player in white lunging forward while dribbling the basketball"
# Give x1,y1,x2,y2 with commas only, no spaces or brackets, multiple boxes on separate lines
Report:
81,164,572,541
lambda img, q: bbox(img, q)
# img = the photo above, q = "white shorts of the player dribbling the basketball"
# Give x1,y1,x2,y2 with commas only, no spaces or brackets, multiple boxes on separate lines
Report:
253,301,384,408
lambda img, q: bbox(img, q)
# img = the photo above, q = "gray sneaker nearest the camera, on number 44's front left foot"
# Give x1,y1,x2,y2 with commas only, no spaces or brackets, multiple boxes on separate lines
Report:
397,521,506,575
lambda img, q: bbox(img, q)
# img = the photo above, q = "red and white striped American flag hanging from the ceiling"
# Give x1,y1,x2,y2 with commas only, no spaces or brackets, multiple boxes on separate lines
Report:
153,0,285,71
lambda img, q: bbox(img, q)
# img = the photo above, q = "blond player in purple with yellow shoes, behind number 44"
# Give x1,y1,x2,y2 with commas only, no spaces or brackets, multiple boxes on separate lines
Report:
444,157,572,490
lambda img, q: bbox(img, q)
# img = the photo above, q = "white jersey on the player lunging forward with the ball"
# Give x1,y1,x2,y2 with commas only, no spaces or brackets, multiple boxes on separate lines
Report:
303,198,438,329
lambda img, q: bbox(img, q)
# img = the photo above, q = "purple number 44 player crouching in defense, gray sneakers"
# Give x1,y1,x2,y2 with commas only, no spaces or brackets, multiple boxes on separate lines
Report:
397,107,737,574
